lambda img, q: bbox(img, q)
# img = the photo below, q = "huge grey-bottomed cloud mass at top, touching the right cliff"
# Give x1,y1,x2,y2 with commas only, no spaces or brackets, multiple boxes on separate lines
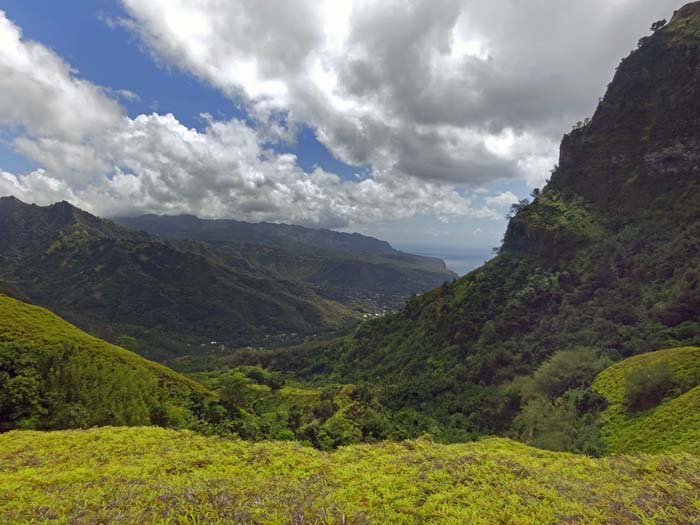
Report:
122,0,679,187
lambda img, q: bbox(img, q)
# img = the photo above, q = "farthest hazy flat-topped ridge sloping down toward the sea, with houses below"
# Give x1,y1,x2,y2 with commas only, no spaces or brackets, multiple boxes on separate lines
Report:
114,215,457,309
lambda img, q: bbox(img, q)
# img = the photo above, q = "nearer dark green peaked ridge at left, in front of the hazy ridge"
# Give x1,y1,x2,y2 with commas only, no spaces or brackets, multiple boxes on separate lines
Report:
0,197,356,358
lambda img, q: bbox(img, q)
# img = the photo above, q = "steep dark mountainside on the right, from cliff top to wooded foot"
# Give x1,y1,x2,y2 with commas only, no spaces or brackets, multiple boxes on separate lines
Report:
246,2,700,442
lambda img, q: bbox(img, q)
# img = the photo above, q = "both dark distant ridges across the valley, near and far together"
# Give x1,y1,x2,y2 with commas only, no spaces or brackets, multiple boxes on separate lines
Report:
0,197,452,358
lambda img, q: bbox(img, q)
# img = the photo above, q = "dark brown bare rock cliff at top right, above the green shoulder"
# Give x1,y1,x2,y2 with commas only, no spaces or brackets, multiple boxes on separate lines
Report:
551,3,700,218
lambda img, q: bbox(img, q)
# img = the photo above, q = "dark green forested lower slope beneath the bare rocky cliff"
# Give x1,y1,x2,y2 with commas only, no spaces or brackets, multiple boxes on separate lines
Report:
250,192,700,440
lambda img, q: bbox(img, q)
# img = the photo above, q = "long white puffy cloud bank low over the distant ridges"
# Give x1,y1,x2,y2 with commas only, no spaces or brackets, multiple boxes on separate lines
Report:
0,9,493,227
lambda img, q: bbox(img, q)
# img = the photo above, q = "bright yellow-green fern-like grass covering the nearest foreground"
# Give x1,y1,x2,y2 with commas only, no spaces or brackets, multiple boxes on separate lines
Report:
0,427,700,525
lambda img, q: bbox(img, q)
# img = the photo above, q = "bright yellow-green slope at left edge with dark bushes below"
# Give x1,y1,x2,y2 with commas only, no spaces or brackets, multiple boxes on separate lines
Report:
0,295,209,430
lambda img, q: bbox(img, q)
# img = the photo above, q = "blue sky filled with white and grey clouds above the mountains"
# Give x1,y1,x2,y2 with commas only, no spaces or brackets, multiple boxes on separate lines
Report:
0,0,684,270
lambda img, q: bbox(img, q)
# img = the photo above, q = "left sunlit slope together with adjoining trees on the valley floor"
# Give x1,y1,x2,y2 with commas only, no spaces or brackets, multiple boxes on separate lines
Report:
0,295,400,449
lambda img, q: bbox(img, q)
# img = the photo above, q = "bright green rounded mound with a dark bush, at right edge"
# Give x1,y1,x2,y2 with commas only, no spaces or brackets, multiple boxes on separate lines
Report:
593,347,700,454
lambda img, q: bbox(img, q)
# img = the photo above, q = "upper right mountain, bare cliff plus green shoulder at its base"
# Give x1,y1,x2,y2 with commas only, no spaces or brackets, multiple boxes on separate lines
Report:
504,2,700,264
